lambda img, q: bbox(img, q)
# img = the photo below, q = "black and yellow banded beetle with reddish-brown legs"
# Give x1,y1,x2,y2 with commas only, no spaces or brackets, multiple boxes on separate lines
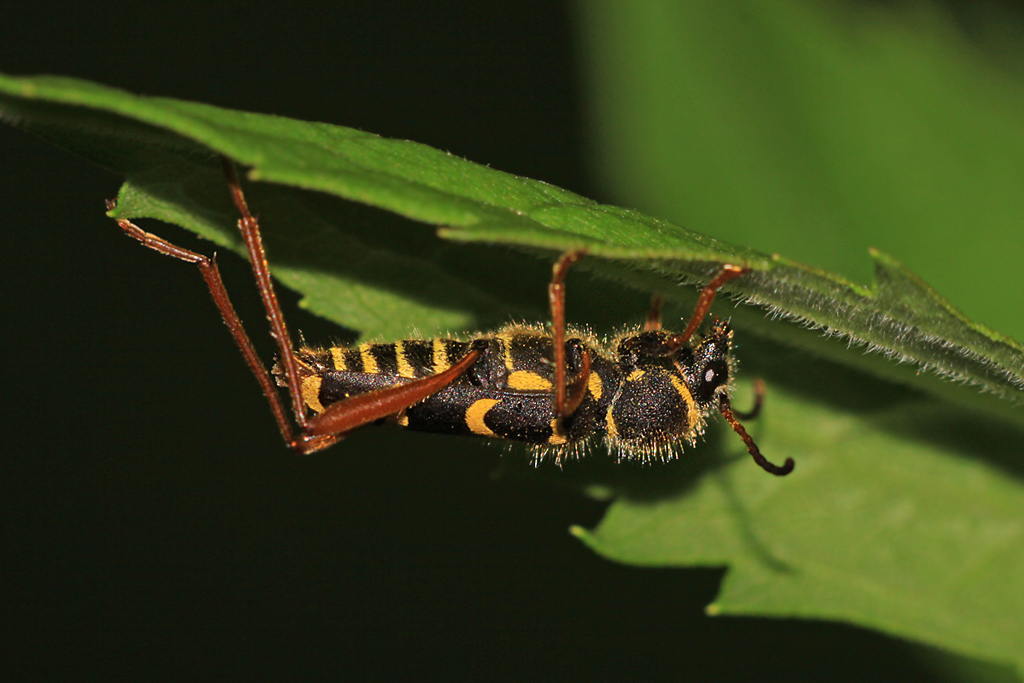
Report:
111,160,794,475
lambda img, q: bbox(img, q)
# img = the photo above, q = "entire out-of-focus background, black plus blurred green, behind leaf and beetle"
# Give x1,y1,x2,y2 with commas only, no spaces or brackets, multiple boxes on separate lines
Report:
0,1,1024,681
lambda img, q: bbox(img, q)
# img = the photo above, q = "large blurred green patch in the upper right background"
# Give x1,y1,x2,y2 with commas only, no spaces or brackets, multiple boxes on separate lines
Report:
578,0,1024,339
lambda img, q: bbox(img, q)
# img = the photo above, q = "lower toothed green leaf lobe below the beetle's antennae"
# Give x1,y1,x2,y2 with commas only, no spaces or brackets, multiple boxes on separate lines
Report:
575,357,1024,666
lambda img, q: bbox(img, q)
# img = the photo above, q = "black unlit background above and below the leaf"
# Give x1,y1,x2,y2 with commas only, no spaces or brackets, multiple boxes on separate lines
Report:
0,2,991,681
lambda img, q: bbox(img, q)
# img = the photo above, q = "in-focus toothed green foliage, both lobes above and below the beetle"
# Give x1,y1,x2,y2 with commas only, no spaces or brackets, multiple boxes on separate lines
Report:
0,72,1024,675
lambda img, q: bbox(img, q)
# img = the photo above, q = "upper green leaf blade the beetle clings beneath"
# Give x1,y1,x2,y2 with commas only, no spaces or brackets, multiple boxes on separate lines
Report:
0,78,1024,411
